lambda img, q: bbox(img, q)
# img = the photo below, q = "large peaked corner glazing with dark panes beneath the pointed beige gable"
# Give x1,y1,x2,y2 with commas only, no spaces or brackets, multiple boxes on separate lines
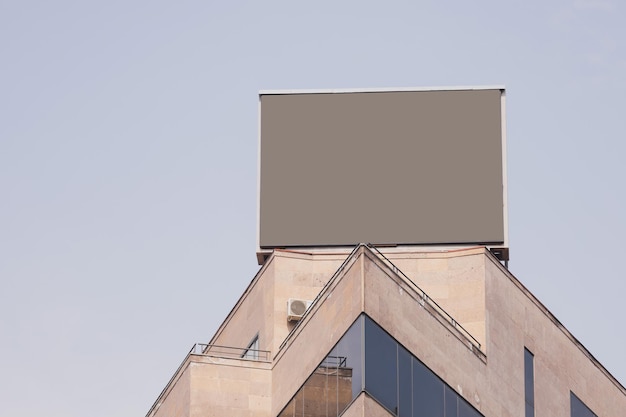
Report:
279,315,486,417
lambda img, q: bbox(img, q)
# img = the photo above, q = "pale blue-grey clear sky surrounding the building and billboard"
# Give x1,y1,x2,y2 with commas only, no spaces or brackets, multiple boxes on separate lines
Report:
0,0,626,417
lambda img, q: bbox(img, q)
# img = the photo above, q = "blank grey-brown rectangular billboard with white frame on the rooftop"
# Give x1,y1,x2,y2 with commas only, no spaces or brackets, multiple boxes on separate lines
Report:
258,88,507,248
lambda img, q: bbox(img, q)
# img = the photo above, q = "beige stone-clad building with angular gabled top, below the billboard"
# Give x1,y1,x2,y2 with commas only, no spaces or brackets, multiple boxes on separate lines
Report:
147,245,626,417
